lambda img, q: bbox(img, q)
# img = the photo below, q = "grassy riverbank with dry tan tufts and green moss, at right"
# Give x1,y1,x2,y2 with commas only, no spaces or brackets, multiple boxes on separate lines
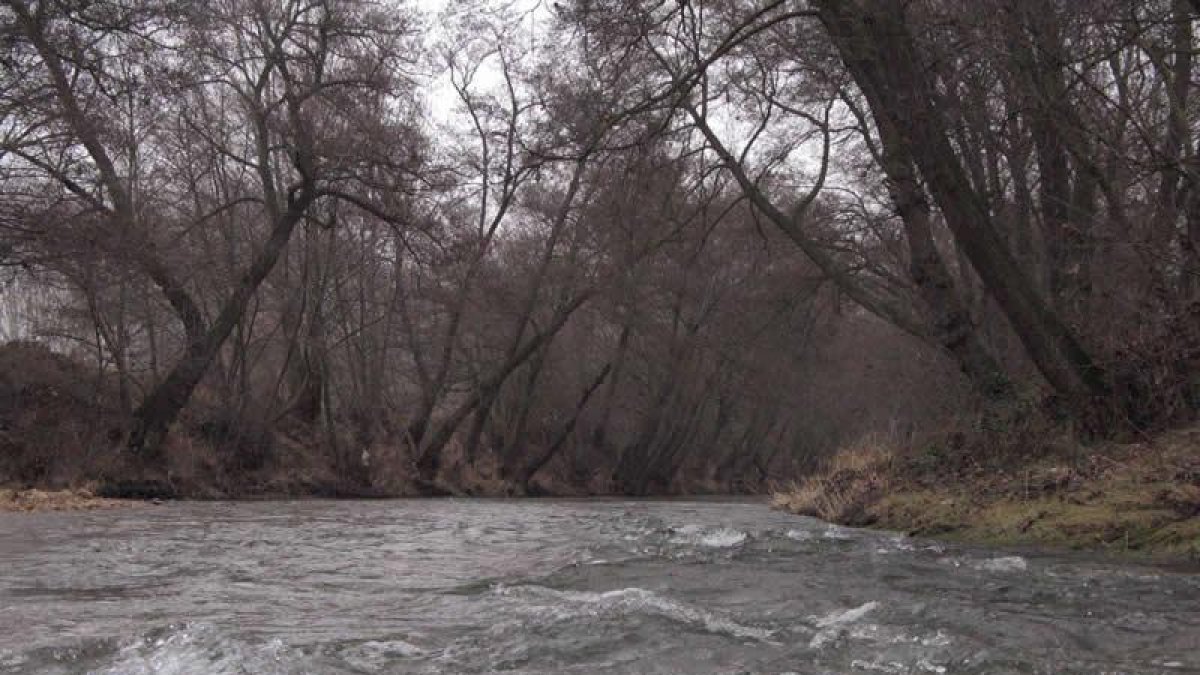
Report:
772,426,1200,563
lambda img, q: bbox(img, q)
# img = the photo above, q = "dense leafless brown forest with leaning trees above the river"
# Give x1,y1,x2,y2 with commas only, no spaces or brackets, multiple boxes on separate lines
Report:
0,0,1200,510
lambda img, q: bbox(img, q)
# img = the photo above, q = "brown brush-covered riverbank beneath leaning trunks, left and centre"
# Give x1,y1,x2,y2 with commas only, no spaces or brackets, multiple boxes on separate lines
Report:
0,342,753,499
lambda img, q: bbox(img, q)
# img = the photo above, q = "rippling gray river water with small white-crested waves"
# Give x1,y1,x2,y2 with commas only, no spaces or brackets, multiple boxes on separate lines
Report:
0,500,1200,674
